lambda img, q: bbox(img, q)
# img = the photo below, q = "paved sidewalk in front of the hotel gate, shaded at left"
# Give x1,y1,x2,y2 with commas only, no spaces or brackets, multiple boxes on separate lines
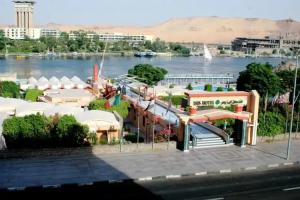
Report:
0,140,300,188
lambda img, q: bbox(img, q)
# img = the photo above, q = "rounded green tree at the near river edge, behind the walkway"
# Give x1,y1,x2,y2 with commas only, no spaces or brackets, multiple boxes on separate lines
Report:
128,64,168,85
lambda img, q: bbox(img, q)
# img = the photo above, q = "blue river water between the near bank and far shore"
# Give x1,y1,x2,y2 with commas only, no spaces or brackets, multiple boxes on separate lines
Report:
0,56,290,80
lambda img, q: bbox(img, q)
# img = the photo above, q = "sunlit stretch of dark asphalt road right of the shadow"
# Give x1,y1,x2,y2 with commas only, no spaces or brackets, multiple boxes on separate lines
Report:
142,167,300,200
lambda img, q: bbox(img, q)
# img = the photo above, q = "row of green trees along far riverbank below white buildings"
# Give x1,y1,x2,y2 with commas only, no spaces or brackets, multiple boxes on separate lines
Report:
0,30,190,56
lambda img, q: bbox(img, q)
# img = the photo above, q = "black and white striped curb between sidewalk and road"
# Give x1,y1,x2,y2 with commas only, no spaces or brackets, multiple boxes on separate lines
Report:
0,161,300,193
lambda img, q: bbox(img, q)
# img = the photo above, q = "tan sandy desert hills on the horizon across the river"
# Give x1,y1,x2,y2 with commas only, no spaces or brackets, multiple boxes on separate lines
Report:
2,17,300,43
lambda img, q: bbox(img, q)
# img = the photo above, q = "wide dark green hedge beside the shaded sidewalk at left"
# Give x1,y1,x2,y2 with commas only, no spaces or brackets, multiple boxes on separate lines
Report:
3,114,89,148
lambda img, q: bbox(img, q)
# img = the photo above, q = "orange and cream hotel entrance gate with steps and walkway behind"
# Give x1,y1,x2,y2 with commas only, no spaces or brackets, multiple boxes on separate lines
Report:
126,88,259,151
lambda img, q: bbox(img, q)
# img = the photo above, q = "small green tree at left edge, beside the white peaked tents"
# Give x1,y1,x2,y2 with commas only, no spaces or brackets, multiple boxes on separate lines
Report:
0,81,20,98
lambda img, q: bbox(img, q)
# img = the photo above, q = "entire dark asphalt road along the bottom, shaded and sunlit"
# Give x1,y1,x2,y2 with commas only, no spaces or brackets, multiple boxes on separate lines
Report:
0,167,300,200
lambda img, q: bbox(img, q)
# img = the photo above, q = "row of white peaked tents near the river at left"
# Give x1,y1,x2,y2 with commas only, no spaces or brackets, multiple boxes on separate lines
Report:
20,76,89,91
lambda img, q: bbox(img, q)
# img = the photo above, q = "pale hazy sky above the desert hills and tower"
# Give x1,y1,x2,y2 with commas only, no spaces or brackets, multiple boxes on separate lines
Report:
0,0,300,26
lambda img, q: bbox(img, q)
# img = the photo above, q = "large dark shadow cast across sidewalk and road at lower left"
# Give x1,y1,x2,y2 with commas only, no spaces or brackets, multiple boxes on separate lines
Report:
0,147,161,199
